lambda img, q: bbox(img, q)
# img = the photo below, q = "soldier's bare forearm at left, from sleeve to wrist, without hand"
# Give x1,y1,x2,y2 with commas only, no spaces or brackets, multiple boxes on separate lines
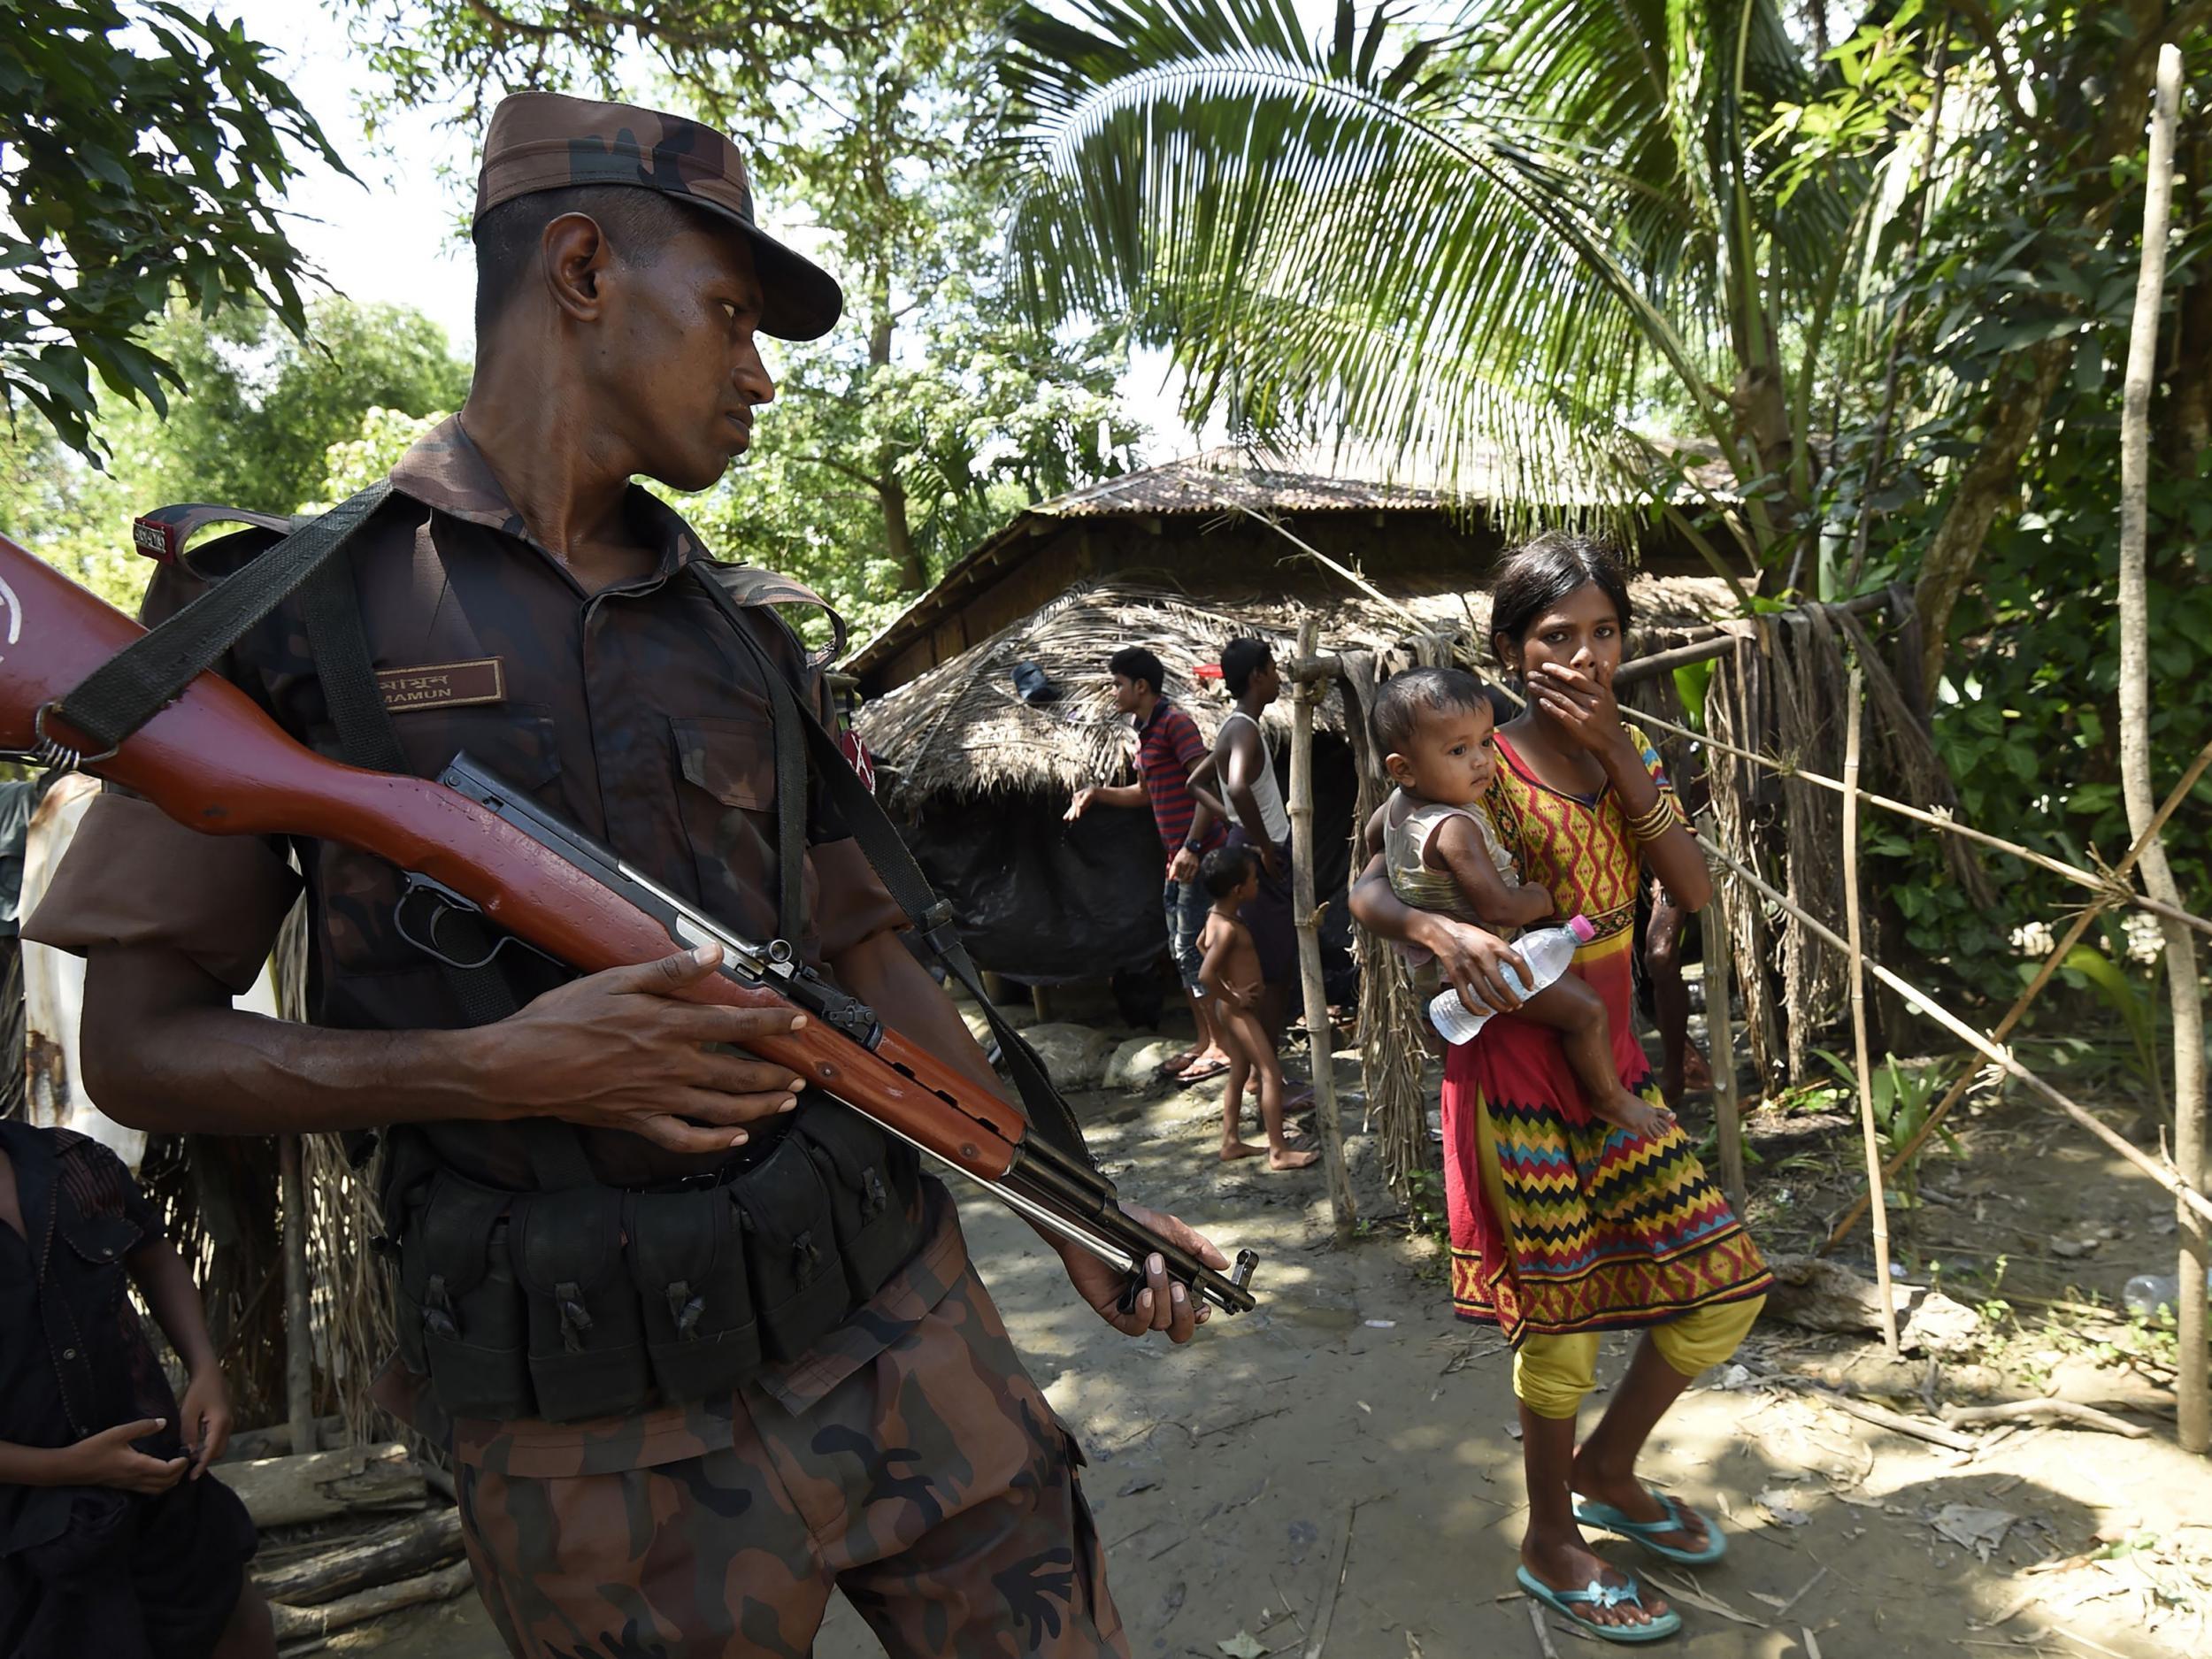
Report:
84,949,504,1135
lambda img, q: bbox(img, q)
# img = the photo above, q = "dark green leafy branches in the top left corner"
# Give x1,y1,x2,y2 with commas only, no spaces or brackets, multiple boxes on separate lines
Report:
0,0,345,454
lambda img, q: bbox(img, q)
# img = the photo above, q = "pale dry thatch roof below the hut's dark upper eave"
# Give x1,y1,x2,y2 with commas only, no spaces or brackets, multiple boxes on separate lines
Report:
858,573,1730,803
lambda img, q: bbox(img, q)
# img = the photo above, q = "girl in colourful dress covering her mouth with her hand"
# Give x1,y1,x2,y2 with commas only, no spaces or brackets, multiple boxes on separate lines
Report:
1352,535,1770,1641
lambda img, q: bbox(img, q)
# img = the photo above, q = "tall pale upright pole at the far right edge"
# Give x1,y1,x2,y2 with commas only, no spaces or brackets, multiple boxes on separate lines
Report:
2119,44,2212,1451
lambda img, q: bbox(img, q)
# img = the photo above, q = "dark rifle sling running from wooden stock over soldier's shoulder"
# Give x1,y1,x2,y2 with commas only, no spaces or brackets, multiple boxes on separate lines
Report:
53,478,392,755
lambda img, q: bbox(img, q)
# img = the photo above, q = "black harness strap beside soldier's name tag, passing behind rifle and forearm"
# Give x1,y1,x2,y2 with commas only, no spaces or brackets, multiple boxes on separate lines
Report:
303,540,597,1193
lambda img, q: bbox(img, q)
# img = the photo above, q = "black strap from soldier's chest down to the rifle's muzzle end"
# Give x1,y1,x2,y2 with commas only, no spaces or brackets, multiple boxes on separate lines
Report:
693,565,1097,1171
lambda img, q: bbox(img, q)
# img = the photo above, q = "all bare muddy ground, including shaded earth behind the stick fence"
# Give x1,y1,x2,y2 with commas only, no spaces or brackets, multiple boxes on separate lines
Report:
307,1000,2212,1659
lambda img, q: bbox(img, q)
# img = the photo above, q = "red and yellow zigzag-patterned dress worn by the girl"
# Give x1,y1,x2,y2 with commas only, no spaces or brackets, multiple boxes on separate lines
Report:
1445,726,1772,1345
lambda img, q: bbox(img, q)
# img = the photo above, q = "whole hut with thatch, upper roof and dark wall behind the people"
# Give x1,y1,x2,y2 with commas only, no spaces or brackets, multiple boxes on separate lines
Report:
848,451,1728,985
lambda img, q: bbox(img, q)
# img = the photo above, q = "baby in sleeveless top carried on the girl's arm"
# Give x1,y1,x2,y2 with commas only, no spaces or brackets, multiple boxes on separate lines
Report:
1374,668,1672,1135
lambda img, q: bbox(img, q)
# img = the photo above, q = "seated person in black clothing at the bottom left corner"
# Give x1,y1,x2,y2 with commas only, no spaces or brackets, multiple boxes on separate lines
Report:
0,1122,277,1659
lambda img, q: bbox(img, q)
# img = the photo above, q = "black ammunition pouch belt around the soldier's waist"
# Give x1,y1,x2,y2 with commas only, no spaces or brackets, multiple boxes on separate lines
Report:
383,1093,923,1423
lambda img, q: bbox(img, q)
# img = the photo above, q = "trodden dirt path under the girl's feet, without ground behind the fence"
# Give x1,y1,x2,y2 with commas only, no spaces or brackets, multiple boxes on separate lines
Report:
349,1057,2212,1659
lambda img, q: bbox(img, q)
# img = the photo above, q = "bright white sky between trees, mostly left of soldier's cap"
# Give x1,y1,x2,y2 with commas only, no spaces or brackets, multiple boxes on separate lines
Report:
212,0,1219,460
